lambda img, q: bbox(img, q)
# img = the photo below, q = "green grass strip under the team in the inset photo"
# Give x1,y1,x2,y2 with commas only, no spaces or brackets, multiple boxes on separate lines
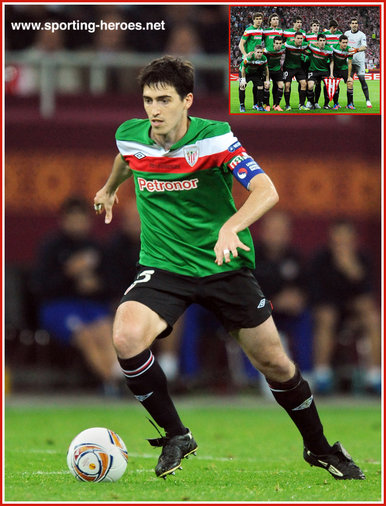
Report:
230,81,380,116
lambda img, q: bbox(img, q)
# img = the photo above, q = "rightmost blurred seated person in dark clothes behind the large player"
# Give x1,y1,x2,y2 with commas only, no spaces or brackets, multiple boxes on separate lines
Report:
310,219,381,393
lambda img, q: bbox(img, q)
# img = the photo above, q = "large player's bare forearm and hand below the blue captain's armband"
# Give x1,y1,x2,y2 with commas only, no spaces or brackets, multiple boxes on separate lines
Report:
214,173,279,265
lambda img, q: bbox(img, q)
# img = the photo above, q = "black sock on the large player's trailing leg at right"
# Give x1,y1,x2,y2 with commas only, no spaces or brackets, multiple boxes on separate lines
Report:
266,370,331,455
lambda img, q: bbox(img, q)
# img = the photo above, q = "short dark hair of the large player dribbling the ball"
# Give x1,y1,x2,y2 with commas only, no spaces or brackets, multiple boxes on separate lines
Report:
138,55,194,99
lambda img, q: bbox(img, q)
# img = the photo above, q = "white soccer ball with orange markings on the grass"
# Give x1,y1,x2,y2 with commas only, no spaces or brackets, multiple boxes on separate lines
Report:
67,427,128,482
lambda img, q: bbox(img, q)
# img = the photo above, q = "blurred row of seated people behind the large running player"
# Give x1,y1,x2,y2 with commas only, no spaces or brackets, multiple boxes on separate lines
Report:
6,196,381,395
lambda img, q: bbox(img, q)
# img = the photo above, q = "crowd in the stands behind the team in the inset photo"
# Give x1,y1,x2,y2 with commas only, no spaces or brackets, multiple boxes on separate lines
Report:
230,5,380,68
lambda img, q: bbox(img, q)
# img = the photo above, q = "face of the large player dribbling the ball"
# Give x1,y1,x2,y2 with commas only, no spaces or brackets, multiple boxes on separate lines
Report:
143,83,193,136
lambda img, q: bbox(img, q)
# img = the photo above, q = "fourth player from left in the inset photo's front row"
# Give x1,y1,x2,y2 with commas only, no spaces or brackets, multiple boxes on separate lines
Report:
307,33,334,109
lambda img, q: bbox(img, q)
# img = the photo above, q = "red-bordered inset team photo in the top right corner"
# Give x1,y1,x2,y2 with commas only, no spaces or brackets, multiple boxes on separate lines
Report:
229,5,381,114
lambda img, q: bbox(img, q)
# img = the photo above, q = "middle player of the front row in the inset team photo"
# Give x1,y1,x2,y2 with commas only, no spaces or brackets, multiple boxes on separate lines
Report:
283,32,308,111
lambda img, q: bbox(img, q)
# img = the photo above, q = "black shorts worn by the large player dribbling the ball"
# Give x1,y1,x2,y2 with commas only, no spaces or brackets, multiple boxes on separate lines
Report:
121,266,272,338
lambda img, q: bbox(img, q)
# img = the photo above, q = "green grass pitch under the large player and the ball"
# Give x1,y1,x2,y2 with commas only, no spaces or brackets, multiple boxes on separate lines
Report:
4,397,381,503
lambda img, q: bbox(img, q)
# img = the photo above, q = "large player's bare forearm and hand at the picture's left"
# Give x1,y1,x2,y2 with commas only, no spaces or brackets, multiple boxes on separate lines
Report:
94,153,132,223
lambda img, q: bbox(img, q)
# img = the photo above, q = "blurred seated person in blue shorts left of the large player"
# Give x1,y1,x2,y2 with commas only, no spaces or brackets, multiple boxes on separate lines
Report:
32,197,120,393
